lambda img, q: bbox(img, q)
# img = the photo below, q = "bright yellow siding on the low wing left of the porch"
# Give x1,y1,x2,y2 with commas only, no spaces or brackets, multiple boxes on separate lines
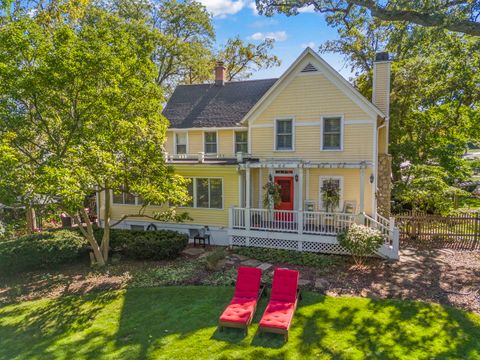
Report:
100,165,238,226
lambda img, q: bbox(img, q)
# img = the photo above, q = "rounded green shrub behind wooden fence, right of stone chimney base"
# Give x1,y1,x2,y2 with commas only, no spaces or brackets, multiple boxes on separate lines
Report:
393,165,468,214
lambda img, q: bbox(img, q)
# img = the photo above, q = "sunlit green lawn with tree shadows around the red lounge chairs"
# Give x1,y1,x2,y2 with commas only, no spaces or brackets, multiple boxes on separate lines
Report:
0,287,480,360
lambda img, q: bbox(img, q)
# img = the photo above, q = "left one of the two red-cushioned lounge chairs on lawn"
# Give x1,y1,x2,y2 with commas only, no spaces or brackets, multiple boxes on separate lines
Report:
218,267,263,336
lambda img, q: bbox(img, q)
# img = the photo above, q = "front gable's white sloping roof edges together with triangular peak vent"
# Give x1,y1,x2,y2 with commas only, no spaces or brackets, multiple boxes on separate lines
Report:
241,47,386,124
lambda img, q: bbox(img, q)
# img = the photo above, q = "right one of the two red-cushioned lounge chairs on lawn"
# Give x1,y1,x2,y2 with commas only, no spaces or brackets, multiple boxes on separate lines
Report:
259,269,300,341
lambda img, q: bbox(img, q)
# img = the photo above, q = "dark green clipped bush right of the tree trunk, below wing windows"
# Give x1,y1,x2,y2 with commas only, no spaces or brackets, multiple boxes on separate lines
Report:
105,229,188,260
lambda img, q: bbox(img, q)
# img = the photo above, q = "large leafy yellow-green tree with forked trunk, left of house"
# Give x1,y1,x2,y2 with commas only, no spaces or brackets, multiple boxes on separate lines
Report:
0,2,188,265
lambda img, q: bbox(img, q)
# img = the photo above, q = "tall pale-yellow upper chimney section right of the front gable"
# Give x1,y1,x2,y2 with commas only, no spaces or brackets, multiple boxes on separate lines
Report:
372,52,392,116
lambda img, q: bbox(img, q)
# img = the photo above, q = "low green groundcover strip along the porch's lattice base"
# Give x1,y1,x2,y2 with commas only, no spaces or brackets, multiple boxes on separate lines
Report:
235,247,339,269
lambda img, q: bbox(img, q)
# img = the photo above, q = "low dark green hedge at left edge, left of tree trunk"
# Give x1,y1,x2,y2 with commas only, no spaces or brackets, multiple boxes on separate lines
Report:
0,230,87,273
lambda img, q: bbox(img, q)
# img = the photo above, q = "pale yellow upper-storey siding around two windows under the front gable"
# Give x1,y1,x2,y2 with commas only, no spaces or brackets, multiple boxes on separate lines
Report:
251,75,374,161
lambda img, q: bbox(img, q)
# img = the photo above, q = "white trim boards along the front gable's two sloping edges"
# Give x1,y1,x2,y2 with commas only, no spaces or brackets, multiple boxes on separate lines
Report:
240,47,386,123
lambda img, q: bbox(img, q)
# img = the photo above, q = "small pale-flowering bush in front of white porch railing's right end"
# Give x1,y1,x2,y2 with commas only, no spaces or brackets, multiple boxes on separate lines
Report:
337,224,384,265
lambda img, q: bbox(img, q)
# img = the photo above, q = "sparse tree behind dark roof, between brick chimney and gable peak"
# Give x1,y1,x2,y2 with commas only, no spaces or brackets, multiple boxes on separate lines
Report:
216,36,280,81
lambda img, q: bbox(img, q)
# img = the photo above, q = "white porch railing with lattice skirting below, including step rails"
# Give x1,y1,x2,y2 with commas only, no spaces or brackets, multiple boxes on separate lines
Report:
228,207,399,259
